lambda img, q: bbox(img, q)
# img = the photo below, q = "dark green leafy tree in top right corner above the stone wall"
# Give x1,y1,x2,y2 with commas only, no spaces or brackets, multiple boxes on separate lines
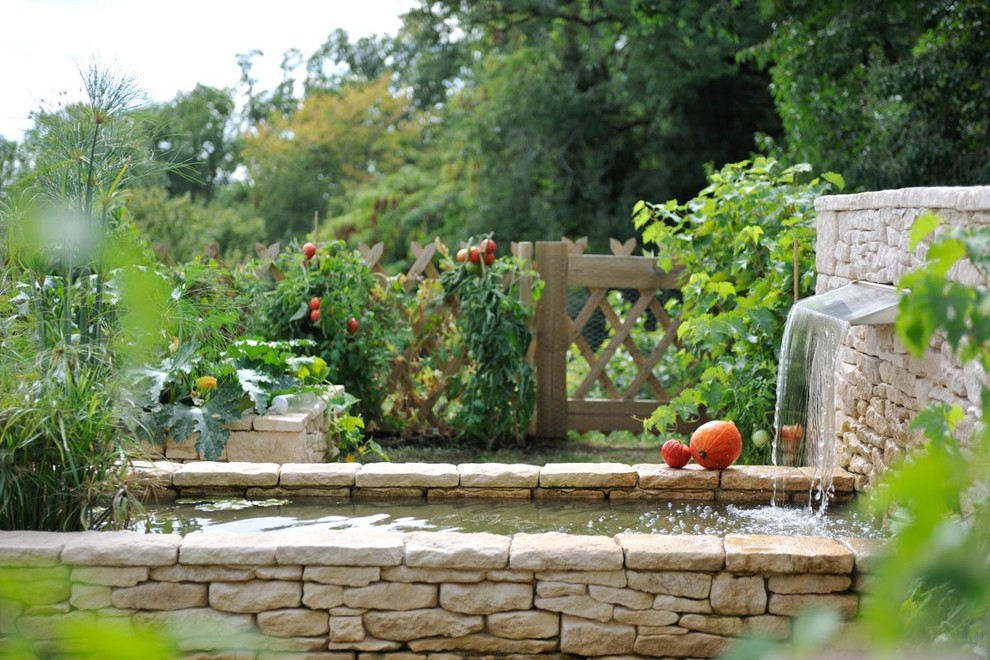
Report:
751,0,990,190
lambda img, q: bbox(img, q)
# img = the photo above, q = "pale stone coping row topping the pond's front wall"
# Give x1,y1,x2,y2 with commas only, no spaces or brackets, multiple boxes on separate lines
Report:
0,530,883,575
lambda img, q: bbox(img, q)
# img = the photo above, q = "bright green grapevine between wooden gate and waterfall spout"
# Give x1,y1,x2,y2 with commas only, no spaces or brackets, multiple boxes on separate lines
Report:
633,158,842,463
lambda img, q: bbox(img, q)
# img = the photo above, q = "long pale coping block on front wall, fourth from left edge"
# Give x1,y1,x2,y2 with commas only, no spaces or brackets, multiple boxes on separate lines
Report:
275,527,404,566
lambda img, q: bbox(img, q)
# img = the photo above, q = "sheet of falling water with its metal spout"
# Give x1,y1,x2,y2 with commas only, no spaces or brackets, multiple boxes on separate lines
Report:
772,282,900,513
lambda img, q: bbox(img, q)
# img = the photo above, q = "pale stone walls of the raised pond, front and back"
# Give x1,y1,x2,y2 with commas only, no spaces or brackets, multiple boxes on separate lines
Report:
0,463,877,660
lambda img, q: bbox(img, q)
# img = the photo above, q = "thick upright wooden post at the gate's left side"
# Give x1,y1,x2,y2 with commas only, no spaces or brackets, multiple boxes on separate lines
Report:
536,241,568,438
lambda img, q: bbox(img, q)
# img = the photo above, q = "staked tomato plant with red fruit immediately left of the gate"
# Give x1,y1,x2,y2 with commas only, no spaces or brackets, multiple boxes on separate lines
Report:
441,237,539,448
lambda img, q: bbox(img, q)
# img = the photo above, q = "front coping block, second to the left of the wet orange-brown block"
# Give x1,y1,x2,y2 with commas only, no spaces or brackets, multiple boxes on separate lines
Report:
509,532,623,571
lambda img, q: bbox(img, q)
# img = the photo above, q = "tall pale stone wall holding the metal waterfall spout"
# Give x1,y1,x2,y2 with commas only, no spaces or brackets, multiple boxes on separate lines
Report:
815,186,990,488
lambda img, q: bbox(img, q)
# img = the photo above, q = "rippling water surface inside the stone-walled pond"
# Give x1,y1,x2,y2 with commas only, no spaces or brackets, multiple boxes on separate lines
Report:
139,498,886,538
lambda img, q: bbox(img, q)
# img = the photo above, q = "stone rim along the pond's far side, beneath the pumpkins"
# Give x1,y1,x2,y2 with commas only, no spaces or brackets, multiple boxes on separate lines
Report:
133,461,855,503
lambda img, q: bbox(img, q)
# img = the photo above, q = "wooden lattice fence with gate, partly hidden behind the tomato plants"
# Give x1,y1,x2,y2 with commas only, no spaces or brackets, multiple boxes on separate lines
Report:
165,239,684,437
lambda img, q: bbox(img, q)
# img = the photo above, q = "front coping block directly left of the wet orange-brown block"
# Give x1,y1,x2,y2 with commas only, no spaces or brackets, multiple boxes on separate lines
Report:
615,534,725,571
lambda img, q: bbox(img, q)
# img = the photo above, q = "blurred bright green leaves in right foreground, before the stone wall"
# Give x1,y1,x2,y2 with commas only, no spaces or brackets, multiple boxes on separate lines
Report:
863,216,990,657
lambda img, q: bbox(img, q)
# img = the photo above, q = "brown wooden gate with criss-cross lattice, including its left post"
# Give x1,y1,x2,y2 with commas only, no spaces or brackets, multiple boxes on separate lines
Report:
533,240,679,437
